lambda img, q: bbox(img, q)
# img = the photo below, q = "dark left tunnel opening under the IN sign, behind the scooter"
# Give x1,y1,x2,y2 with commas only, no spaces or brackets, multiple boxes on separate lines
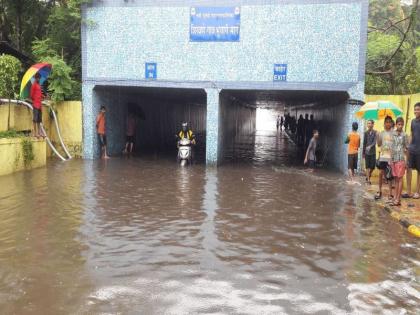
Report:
94,86,206,163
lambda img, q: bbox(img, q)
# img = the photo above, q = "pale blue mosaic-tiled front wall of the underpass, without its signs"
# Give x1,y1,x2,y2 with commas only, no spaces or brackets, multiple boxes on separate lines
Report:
82,0,368,163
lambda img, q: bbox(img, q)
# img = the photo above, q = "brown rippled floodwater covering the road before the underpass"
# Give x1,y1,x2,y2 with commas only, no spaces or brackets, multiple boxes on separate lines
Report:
0,130,420,315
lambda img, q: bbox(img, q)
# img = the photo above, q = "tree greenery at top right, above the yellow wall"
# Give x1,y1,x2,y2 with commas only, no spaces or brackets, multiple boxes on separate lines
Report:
365,0,420,94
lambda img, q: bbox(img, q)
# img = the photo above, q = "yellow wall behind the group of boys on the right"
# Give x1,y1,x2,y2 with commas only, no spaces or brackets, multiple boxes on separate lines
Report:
365,93,420,190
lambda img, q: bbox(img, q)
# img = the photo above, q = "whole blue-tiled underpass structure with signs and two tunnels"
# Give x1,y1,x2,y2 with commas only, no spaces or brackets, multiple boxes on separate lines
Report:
82,0,368,170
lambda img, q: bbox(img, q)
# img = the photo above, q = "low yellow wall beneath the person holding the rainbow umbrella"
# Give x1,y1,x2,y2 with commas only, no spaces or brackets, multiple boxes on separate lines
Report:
0,138,46,175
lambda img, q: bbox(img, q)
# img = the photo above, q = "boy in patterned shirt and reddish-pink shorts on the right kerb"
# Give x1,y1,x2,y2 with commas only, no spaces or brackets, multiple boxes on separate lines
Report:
391,117,408,206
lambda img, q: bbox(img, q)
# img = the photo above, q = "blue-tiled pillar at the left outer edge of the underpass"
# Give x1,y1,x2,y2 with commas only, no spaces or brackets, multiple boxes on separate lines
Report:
82,83,99,159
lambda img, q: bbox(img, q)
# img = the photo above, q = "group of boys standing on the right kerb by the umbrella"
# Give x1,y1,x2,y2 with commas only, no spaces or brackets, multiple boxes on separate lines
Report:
346,103,420,206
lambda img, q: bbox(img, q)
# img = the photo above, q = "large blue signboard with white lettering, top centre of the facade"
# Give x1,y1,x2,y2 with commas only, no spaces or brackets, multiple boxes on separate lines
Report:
190,7,241,42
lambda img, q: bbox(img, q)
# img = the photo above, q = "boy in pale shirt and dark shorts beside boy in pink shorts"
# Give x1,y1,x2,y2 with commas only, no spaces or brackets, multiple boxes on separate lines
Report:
375,116,394,200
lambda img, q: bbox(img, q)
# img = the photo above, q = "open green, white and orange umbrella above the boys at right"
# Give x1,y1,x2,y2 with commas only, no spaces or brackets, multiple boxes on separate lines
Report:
356,101,403,120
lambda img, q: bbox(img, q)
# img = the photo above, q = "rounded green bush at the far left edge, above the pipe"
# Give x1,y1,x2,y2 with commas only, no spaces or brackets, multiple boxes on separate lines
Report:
0,54,22,98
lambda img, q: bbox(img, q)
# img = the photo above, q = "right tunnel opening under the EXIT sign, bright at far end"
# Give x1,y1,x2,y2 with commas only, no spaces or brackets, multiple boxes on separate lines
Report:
219,90,351,169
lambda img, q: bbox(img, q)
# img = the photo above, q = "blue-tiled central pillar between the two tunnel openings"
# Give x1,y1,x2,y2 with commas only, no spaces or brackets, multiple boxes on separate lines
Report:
206,89,220,165
